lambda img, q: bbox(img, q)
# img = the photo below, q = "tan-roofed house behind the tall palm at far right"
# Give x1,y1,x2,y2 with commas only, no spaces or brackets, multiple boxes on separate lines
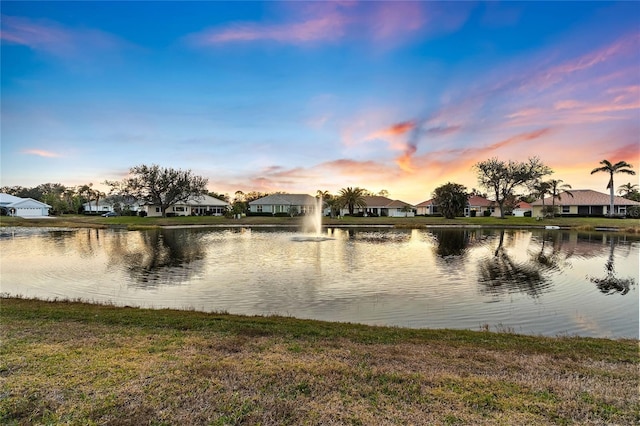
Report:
531,189,640,217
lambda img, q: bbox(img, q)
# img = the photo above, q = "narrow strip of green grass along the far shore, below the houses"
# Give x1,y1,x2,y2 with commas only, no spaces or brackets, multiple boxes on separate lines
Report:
0,215,640,233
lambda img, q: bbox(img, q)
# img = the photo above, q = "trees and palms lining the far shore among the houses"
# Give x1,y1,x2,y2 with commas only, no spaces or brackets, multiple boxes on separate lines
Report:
0,157,640,218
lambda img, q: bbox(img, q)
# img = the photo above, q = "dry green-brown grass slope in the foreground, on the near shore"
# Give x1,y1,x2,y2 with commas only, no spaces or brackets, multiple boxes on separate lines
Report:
0,299,640,425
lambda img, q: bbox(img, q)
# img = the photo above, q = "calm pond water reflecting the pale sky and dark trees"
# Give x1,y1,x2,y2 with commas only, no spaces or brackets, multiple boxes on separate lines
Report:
0,228,640,338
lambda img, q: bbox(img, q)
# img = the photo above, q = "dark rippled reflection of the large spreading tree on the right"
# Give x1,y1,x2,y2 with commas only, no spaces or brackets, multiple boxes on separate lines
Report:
478,229,550,297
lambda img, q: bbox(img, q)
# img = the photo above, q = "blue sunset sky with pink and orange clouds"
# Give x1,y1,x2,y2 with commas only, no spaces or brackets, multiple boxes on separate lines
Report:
0,1,640,204
